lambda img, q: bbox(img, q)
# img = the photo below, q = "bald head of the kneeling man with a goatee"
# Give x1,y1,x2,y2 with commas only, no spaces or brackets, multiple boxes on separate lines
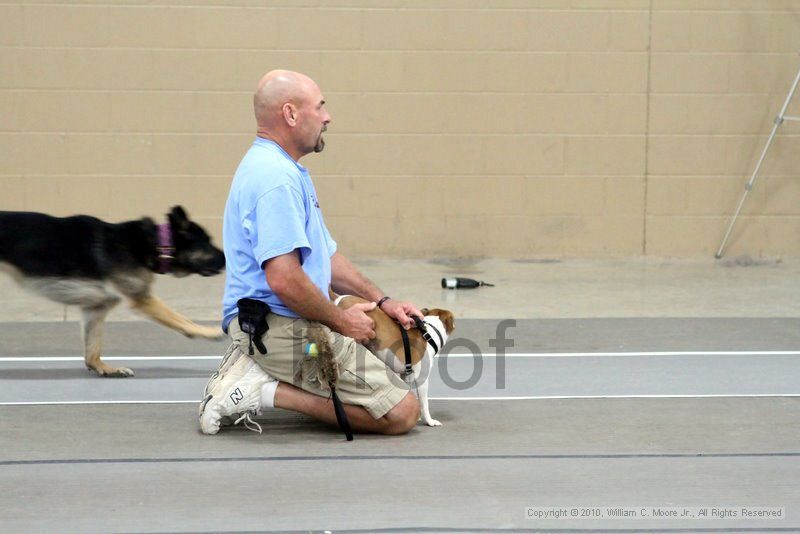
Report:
253,70,331,161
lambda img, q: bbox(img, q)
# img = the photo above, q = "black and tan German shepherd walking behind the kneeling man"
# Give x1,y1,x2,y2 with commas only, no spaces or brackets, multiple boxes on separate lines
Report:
0,206,225,377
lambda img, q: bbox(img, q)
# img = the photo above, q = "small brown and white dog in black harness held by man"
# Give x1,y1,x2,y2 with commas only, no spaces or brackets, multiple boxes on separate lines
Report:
330,290,455,426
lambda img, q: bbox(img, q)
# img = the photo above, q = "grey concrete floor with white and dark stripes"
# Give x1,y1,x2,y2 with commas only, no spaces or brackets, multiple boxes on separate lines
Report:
0,258,800,532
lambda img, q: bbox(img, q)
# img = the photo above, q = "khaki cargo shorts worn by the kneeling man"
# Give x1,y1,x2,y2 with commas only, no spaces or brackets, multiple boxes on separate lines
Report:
228,313,409,419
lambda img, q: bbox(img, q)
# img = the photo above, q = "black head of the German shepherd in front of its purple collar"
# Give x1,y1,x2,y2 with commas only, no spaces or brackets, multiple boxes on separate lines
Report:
167,206,225,276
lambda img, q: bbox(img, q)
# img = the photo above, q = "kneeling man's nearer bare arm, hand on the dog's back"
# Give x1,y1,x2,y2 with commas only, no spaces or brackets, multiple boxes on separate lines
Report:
264,251,375,343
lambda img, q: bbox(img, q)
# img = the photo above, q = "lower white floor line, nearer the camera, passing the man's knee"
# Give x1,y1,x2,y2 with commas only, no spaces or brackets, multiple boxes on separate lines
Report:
0,393,800,406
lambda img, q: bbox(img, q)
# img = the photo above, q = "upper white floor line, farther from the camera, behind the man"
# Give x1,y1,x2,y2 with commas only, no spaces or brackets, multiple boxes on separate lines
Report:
0,350,800,363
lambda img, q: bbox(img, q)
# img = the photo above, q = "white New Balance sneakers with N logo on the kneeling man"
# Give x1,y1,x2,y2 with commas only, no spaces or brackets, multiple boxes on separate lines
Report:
200,351,275,434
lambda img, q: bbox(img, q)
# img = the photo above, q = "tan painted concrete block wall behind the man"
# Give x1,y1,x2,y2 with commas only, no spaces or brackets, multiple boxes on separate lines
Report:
0,0,800,257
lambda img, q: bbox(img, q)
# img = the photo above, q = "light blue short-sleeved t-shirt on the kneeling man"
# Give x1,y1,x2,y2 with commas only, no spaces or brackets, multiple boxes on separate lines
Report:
222,137,336,332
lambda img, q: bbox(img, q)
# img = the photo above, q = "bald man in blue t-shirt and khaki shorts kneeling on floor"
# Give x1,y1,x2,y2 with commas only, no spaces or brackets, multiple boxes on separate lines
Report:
200,70,422,434
